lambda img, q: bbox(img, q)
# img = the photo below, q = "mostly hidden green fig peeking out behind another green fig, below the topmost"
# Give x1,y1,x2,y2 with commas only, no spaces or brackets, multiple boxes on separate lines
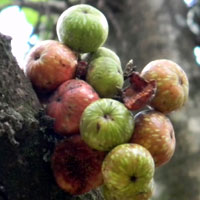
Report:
88,47,121,66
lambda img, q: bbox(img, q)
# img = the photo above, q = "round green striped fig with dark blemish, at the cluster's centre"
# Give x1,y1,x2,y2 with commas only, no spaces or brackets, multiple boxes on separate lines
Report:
80,98,134,151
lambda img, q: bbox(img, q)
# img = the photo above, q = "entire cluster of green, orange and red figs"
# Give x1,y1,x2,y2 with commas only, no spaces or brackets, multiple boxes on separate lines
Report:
24,4,189,200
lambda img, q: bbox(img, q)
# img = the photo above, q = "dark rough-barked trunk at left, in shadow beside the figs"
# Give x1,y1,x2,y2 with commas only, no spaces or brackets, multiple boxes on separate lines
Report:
0,34,102,200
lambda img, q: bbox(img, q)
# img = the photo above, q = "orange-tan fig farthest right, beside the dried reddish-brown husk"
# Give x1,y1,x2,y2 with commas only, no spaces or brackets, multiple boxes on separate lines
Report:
141,59,189,113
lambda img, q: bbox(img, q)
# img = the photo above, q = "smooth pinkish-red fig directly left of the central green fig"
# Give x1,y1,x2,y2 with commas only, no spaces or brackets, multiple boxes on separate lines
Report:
47,79,99,135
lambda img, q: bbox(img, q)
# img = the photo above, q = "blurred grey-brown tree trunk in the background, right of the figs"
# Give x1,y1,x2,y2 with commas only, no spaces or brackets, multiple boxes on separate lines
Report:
104,0,200,200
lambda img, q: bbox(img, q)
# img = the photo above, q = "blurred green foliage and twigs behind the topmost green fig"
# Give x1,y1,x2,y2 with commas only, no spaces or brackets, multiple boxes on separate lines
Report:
0,0,125,40
